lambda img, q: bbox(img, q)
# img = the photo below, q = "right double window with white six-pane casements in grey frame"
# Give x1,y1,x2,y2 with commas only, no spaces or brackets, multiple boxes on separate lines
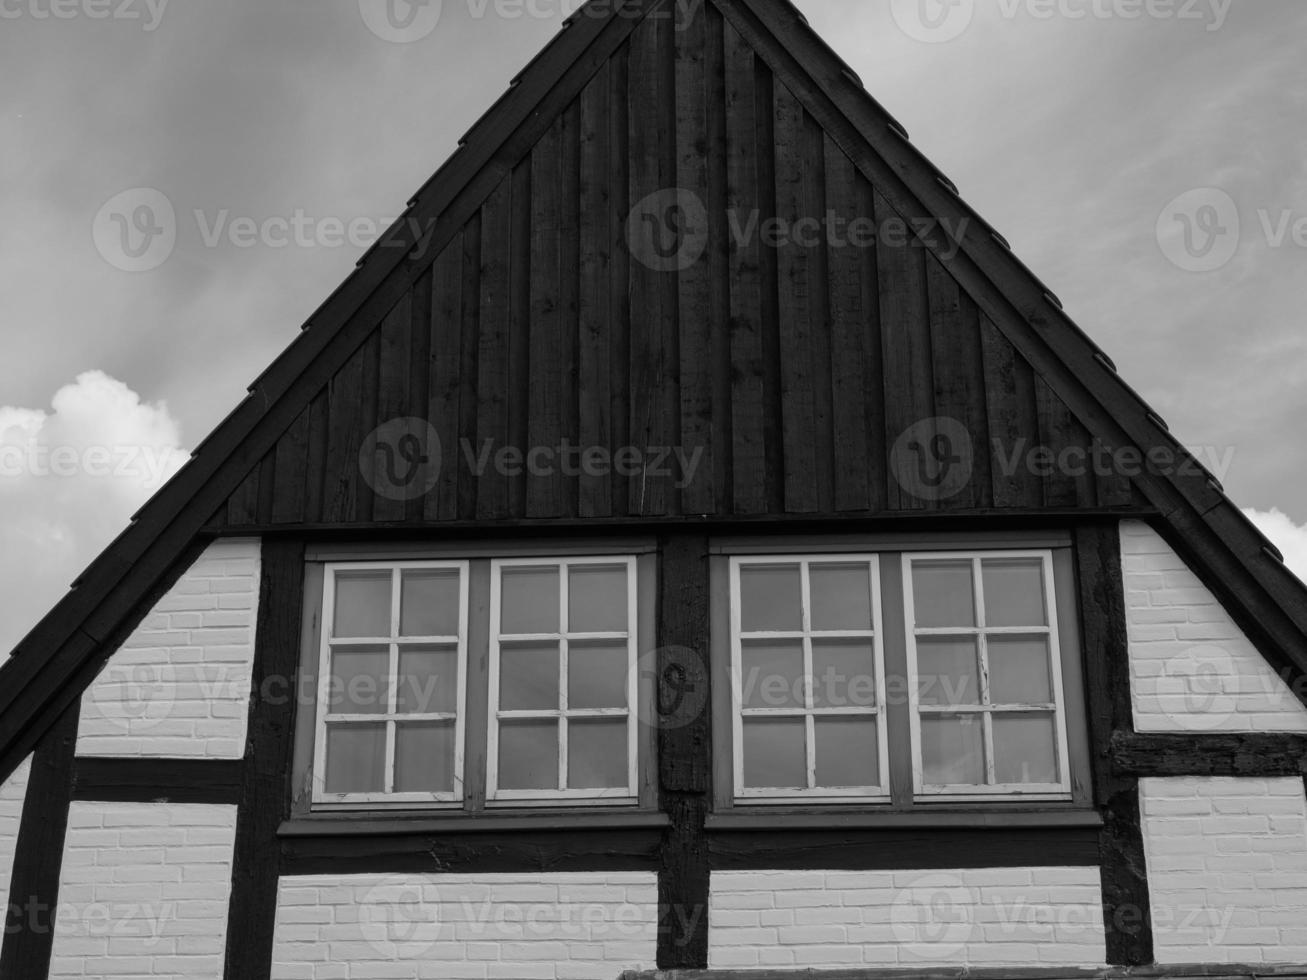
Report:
711,534,1090,810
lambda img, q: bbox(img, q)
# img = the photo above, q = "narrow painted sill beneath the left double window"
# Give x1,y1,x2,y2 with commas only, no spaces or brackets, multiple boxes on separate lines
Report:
277,808,668,838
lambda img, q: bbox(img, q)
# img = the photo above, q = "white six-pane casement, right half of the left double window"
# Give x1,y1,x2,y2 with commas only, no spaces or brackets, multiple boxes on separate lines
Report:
486,557,639,802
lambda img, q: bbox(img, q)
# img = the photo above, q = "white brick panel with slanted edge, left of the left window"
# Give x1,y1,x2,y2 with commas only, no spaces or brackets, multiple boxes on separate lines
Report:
77,538,262,759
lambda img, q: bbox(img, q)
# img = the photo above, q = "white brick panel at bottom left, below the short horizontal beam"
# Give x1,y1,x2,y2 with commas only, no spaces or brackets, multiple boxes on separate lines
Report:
50,802,237,980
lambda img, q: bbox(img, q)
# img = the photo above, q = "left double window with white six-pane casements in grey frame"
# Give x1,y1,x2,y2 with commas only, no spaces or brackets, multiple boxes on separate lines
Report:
294,540,657,815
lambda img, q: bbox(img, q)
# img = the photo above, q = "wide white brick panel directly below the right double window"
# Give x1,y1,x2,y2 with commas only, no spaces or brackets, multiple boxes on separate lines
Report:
708,868,1106,970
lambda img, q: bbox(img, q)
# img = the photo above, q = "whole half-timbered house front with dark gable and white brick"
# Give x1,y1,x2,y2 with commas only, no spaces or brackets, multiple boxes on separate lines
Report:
0,0,1307,980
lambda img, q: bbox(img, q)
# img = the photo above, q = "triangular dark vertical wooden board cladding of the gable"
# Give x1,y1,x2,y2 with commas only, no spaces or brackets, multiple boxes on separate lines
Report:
211,4,1134,528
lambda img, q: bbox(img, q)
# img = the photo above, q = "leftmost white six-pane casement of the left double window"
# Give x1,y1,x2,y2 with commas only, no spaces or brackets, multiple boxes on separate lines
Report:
312,562,468,804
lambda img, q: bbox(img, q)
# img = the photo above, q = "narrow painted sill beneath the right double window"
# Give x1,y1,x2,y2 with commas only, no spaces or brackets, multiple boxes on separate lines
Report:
704,806,1103,831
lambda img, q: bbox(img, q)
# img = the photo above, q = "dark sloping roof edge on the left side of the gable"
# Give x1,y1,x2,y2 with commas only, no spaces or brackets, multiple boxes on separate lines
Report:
0,0,668,779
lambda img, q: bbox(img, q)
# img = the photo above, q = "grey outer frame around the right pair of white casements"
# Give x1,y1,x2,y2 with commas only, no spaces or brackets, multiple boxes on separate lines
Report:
708,531,1097,828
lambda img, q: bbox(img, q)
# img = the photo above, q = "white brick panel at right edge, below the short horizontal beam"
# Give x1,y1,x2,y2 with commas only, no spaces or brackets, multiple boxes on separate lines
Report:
1140,776,1307,963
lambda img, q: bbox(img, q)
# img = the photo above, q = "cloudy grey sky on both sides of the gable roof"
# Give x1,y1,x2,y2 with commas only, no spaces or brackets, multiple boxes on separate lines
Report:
0,0,1307,661
